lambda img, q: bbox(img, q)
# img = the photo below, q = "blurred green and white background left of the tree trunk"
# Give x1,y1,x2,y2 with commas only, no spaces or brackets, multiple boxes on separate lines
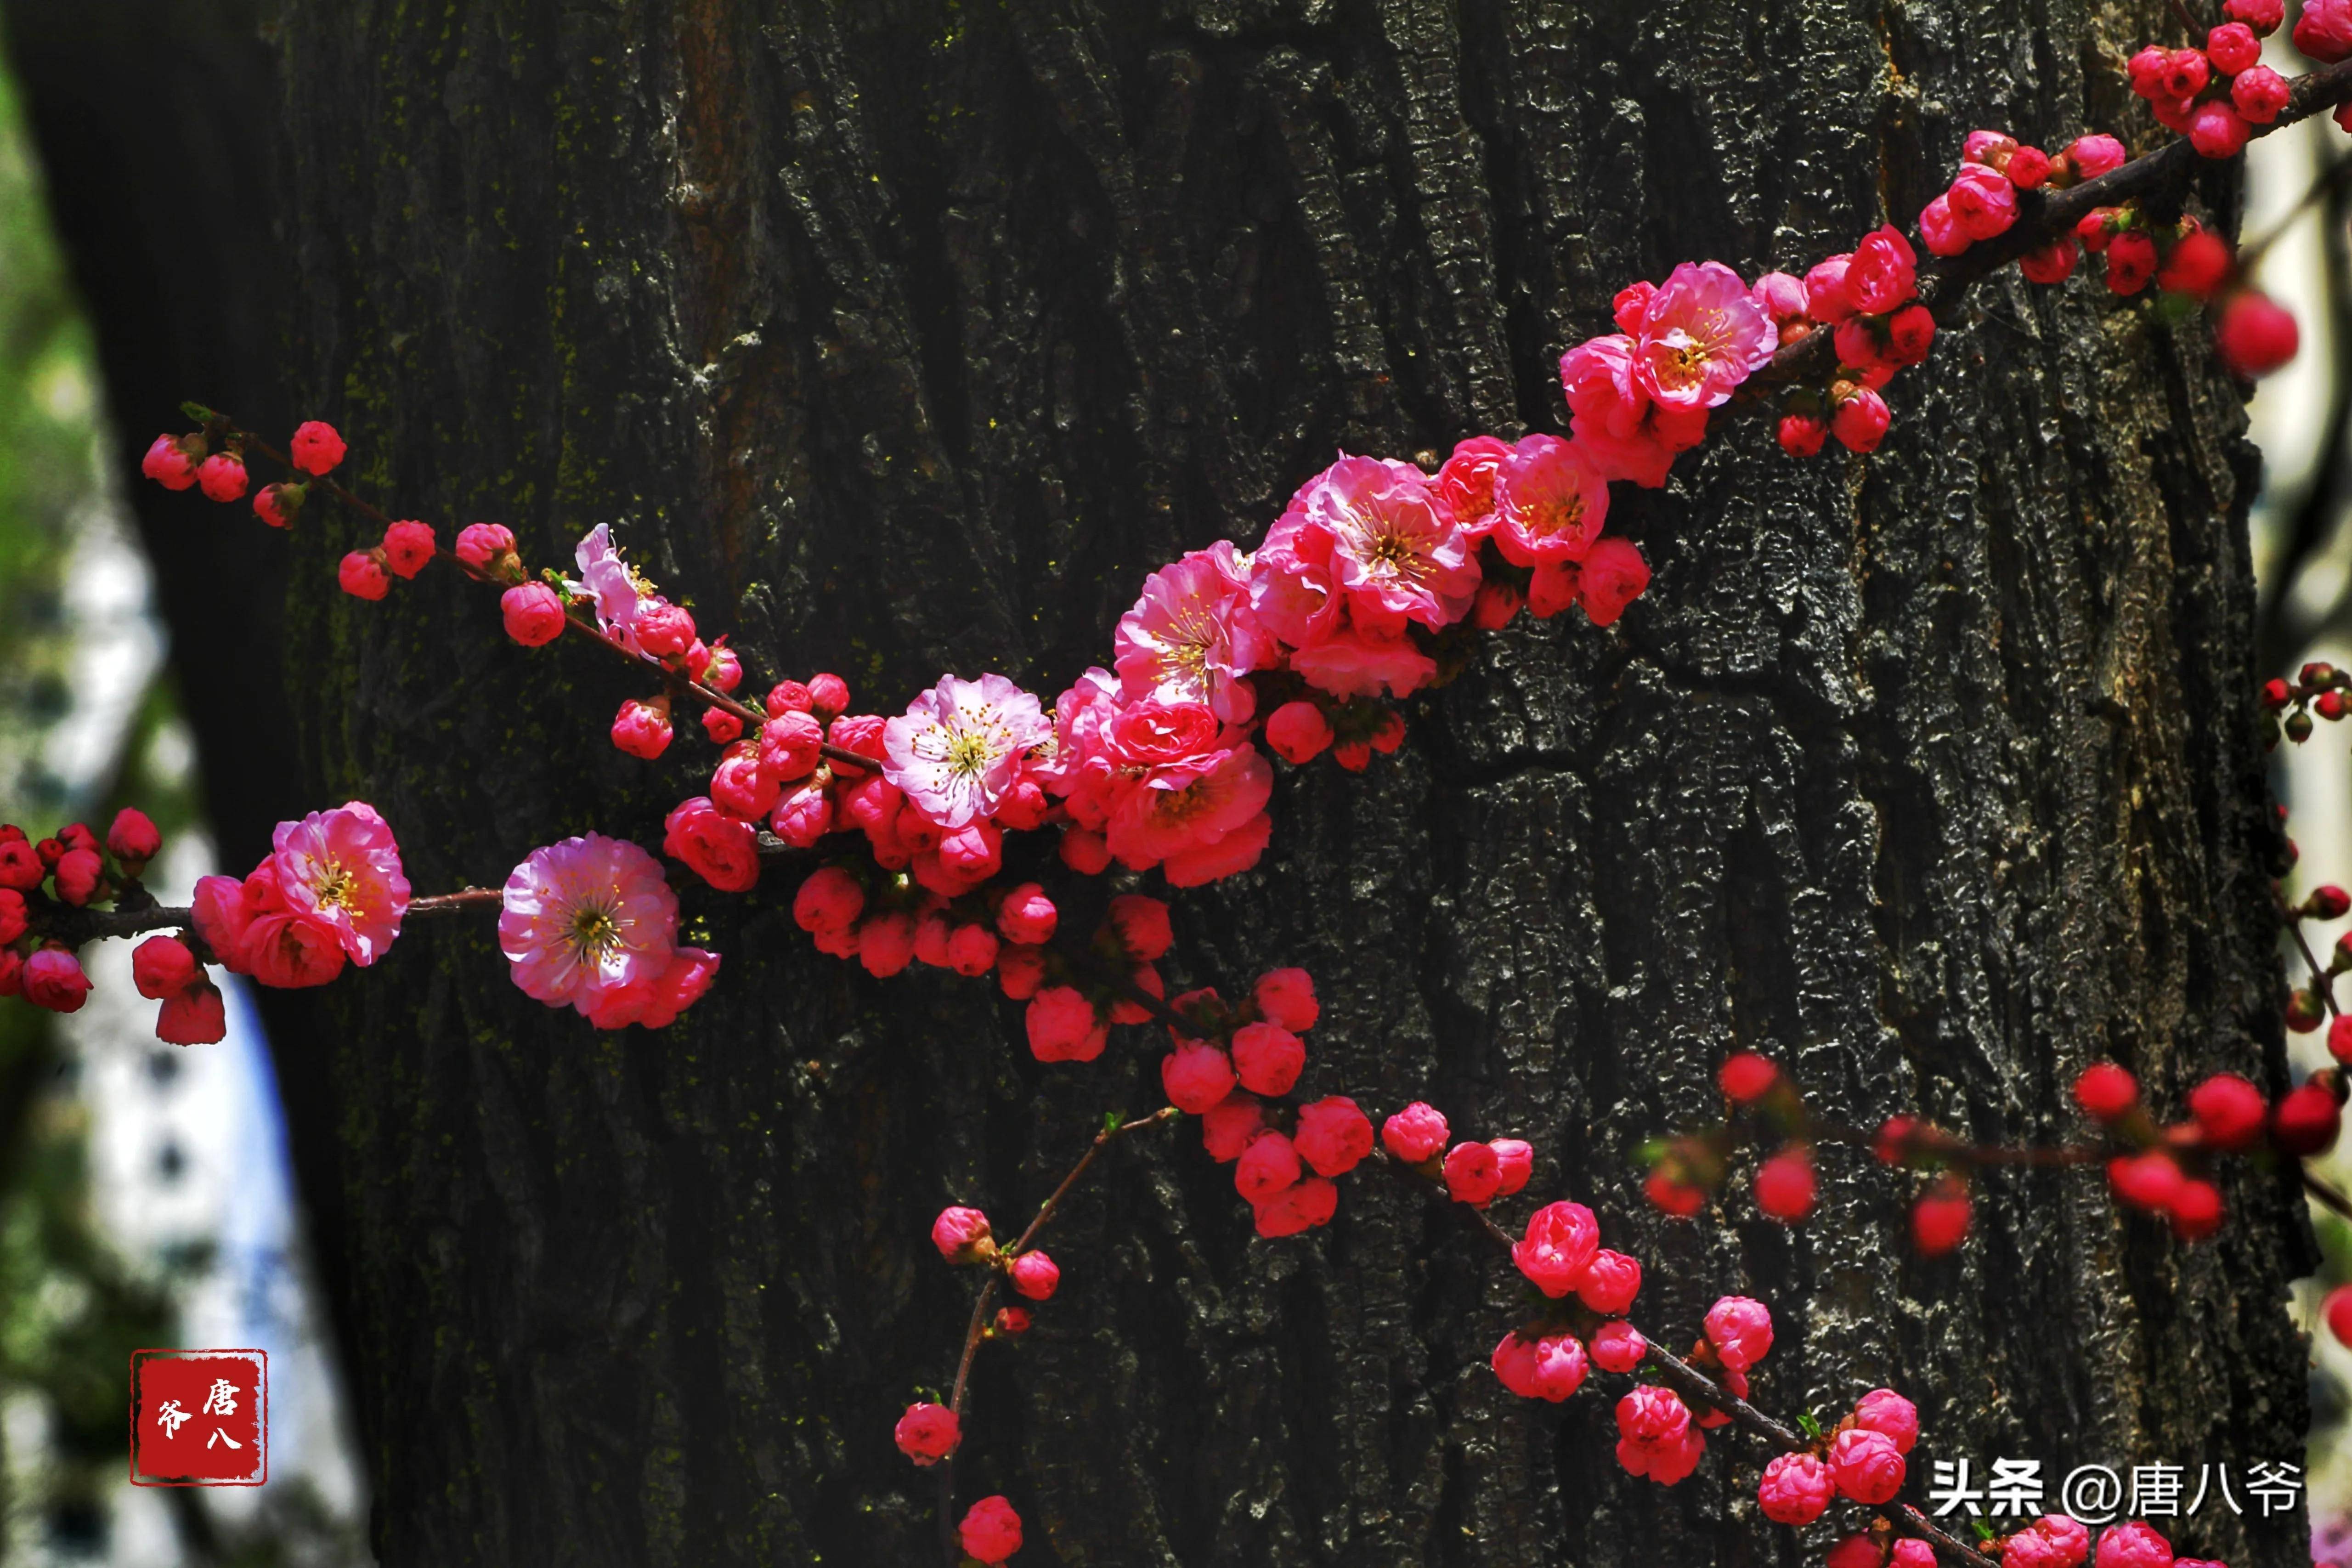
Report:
0,24,369,1568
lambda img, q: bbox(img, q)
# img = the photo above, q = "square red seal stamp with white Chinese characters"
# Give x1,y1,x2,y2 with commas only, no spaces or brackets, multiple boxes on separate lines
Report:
132,1349,271,1486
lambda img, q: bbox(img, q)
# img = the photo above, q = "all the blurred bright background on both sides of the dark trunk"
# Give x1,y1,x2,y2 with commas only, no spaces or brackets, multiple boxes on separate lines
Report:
0,0,2352,1568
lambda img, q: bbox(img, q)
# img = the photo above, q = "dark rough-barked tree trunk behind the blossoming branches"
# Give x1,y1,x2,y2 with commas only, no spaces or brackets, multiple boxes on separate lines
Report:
32,0,2310,1568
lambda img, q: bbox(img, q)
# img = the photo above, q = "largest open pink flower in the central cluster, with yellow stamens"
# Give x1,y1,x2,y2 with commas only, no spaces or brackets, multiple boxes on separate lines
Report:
1291,451,1479,632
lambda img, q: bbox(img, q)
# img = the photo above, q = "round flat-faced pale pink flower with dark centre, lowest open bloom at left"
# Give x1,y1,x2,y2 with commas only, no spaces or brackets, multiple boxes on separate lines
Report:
498,832,678,1027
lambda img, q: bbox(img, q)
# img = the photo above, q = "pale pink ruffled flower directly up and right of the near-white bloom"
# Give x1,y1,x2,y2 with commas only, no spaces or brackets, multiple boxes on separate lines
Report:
1113,538,1275,724
